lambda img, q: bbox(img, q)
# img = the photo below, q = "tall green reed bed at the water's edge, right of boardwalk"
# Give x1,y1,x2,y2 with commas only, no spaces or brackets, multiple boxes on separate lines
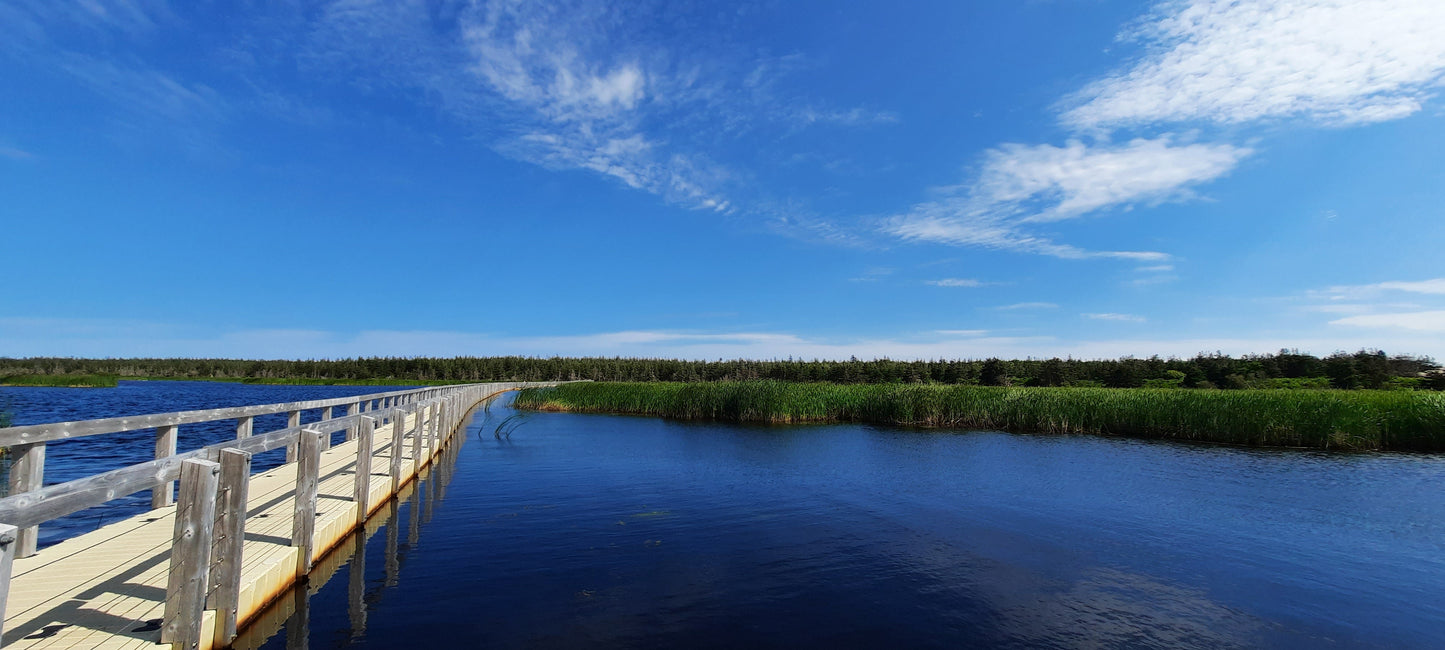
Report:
516,381,1445,451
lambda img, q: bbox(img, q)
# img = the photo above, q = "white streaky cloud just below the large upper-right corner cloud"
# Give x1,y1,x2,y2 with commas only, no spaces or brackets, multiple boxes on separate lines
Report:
883,136,1251,261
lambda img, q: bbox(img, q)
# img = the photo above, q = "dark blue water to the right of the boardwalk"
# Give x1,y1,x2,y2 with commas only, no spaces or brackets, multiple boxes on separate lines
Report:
8,389,1445,649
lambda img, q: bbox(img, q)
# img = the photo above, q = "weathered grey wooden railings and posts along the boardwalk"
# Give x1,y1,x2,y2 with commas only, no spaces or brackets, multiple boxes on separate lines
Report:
0,383,555,647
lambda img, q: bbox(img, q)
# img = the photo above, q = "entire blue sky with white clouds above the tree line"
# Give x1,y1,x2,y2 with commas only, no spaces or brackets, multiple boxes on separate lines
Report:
0,0,1445,358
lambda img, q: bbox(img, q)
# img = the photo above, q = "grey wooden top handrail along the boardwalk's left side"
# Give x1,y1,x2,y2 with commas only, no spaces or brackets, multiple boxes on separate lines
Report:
0,381,456,446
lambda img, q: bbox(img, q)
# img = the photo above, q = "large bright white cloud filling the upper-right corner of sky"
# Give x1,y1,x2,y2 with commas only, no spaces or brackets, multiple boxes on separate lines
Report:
1064,0,1445,129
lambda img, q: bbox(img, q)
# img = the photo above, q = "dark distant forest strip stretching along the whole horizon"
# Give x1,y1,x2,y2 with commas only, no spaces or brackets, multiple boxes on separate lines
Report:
0,350,1445,390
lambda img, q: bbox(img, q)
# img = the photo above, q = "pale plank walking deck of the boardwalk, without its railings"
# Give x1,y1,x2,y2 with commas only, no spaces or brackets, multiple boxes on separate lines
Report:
0,384,551,650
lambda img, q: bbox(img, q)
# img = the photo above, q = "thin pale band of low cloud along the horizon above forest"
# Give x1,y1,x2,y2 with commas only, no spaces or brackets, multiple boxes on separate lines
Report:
0,316,1445,360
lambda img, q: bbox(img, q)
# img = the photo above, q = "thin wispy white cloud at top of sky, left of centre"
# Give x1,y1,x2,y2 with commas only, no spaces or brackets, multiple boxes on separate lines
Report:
450,3,731,212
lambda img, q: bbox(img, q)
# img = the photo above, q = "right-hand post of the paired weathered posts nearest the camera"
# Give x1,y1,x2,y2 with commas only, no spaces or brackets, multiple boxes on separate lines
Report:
205,449,251,647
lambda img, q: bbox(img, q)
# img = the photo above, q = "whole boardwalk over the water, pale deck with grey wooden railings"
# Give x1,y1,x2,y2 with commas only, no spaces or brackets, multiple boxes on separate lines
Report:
0,383,552,649
